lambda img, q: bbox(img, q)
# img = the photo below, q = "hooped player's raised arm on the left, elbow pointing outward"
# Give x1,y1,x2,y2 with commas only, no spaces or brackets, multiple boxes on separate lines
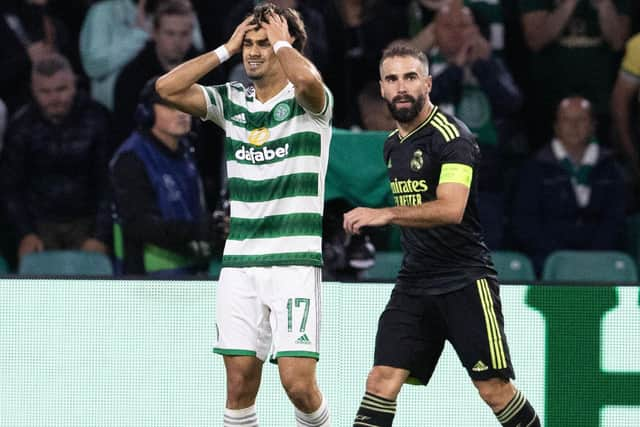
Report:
156,17,255,117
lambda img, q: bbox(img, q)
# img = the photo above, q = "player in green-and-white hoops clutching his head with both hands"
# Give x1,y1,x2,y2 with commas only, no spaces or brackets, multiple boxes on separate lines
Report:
156,3,333,427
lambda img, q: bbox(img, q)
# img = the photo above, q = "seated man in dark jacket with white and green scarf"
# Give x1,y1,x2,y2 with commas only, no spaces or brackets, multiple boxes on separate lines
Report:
512,96,626,271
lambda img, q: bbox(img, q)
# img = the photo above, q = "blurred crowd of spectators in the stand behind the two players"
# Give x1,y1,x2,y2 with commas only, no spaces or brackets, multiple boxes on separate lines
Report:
0,0,640,278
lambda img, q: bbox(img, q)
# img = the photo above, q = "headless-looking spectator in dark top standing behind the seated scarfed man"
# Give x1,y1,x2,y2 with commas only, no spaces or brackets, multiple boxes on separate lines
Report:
519,0,631,149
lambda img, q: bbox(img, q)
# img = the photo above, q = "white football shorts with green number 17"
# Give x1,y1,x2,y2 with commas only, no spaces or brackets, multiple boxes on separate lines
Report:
214,266,322,361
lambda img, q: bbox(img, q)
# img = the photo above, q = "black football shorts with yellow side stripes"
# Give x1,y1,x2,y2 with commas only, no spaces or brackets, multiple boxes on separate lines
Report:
374,278,515,385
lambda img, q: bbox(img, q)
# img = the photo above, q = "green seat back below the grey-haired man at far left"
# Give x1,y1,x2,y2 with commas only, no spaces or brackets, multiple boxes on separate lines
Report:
18,250,113,276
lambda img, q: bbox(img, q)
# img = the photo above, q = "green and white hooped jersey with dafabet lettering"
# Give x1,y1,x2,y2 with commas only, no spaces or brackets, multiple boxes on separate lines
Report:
201,82,333,267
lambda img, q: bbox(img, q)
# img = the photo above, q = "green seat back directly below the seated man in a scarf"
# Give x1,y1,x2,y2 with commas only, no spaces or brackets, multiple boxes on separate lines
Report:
542,251,638,282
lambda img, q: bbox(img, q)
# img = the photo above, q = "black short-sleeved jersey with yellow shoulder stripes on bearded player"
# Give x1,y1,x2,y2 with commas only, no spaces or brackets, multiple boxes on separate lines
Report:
384,107,496,294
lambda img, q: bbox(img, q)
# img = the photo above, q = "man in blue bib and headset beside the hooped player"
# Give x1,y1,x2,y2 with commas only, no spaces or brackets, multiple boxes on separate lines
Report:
110,79,223,277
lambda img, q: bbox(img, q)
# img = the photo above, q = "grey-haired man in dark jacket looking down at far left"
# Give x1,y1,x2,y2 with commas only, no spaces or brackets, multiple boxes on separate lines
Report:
0,54,111,257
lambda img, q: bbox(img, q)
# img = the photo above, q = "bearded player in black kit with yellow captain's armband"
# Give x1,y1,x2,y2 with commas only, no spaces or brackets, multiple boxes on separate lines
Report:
344,45,540,427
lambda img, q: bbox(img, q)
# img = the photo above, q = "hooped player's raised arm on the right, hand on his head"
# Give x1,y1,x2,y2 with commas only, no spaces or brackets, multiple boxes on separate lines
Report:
263,14,325,113
